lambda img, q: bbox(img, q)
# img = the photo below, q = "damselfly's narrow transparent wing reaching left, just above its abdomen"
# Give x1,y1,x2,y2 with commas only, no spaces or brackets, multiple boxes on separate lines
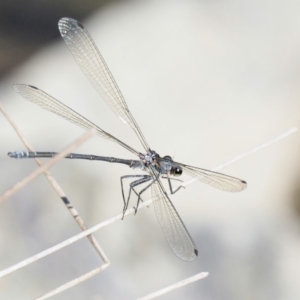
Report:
14,84,139,155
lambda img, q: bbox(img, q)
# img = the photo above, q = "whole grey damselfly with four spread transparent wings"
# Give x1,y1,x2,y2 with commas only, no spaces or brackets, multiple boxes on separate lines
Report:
8,18,247,261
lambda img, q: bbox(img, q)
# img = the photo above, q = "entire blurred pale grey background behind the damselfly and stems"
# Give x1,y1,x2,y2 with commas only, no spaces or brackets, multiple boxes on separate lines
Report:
0,0,300,300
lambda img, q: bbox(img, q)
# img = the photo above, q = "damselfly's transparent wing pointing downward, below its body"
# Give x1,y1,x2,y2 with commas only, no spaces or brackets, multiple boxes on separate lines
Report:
151,171,198,261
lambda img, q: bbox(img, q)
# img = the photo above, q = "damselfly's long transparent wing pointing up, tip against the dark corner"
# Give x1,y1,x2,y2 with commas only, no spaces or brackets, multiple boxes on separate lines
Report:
58,18,149,150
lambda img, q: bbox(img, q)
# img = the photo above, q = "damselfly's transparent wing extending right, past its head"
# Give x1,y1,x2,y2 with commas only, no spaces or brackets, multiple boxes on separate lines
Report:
174,162,247,192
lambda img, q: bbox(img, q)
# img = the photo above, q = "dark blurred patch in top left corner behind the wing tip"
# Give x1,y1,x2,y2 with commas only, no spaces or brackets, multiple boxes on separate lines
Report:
0,0,116,79
